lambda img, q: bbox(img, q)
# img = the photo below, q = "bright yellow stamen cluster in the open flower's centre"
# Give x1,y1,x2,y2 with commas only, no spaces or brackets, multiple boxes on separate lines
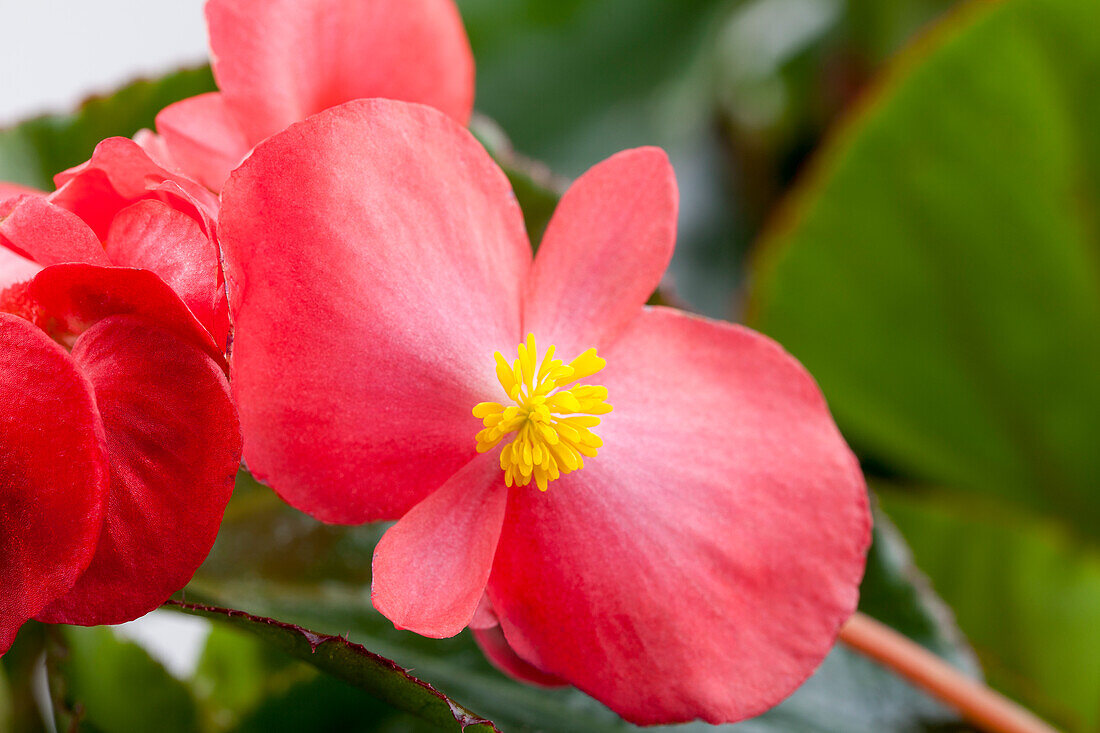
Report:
474,333,612,491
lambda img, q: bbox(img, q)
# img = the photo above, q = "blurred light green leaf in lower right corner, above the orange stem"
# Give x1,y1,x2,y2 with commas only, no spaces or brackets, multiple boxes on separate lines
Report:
881,490,1100,731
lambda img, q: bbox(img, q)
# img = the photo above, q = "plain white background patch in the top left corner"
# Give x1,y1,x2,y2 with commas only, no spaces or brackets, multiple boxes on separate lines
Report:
0,0,207,127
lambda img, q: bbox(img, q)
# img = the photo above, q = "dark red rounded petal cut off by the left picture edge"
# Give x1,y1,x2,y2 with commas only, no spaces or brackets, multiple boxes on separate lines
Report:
0,314,108,654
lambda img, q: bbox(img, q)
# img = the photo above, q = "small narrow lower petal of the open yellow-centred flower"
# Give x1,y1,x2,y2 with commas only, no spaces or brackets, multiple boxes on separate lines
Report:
371,455,508,638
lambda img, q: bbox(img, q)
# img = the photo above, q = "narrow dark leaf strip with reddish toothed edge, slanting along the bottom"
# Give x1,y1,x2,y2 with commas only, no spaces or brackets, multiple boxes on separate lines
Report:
167,601,496,731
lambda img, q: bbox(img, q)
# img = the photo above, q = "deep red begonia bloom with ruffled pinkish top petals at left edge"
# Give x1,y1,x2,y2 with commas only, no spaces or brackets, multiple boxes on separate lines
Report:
0,139,241,654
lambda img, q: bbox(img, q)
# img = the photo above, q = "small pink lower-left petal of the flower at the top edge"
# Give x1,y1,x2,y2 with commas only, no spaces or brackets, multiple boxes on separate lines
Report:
156,91,252,192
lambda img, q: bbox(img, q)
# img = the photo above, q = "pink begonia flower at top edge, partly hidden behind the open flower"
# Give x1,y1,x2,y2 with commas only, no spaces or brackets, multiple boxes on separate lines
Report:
144,0,474,192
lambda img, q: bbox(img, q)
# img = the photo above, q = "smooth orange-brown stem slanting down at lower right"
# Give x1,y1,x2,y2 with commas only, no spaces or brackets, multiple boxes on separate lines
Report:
840,613,1057,733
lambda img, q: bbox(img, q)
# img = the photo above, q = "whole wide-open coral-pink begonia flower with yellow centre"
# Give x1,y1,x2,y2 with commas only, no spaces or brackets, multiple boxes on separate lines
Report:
221,99,870,723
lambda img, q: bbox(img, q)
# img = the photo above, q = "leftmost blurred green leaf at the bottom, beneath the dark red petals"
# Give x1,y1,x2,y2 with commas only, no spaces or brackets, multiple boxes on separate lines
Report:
47,626,199,733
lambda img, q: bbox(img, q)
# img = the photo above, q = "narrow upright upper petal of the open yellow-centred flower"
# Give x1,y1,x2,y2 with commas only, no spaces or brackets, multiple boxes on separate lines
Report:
524,147,679,358
